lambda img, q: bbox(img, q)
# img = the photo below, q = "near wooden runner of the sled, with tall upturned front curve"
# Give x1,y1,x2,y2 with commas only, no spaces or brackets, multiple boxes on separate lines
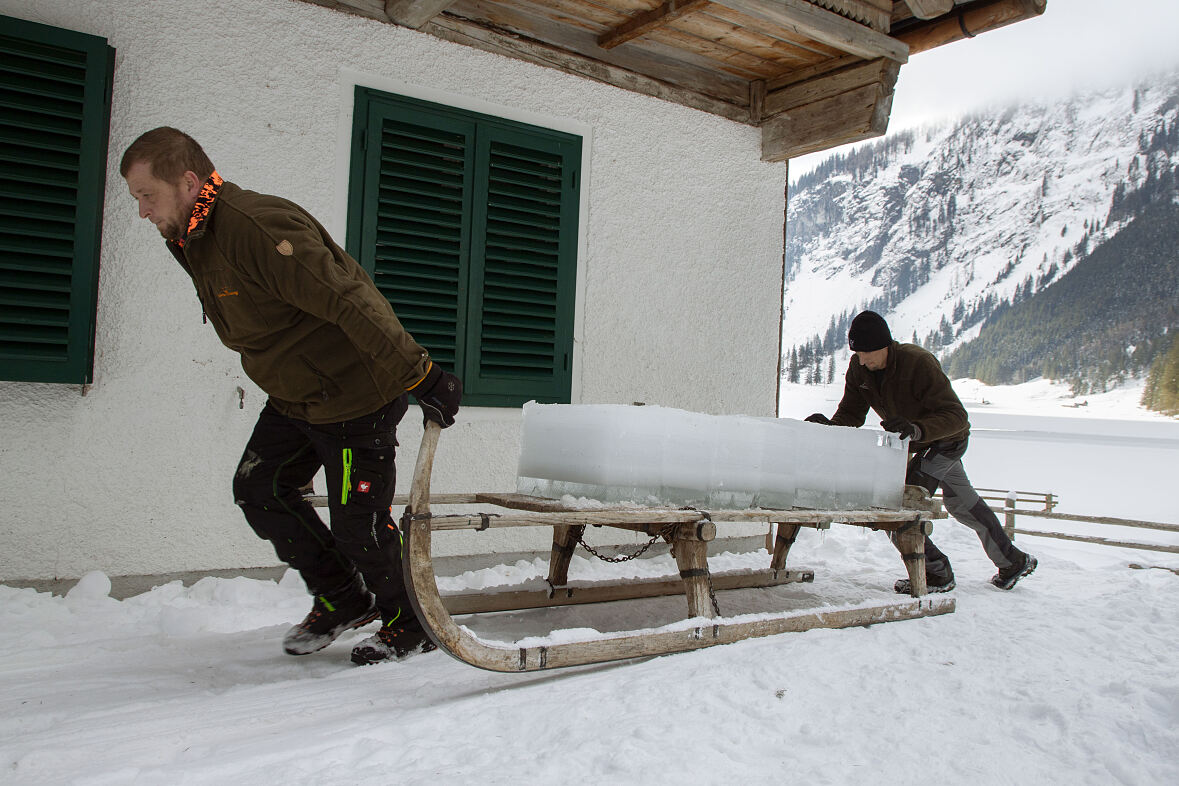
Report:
401,423,954,672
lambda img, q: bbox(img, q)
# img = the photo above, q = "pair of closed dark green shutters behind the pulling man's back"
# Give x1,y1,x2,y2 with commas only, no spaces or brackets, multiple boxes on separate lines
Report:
348,88,581,407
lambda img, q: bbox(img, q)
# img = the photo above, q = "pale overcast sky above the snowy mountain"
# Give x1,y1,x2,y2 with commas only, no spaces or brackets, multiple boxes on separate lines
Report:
790,0,1179,173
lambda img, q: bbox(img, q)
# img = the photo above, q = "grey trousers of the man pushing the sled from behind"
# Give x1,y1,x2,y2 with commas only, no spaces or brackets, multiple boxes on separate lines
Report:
905,438,1023,576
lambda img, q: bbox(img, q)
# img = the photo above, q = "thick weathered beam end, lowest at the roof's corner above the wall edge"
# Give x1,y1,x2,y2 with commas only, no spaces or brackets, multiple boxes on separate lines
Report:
762,78,893,161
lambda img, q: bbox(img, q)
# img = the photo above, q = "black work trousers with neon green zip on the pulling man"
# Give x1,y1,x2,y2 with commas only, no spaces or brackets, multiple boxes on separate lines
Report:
233,395,417,627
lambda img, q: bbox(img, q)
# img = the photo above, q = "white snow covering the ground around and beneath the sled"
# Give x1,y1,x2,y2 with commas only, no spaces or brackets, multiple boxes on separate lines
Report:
0,383,1179,786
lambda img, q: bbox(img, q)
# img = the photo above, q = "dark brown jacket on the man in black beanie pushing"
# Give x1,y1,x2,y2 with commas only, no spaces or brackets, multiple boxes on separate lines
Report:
831,342,970,451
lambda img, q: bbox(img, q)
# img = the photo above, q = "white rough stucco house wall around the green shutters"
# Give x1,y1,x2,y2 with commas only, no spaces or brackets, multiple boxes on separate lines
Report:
0,0,785,580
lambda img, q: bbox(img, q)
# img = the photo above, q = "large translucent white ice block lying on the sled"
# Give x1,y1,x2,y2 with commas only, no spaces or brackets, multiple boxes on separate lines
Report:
516,402,907,509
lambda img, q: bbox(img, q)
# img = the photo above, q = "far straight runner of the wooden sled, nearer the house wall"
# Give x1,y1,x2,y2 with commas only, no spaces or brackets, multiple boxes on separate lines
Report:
442,569,815,615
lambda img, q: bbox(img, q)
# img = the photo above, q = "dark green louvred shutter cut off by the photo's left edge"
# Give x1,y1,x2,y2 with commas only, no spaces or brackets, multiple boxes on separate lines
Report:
0,16,114,383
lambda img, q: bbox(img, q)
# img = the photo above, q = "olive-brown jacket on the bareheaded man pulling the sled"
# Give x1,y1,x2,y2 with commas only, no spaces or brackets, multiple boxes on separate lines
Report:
169,176,430,423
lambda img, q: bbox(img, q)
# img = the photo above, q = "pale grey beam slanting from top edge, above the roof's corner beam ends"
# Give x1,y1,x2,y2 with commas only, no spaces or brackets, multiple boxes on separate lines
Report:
713,0,909,62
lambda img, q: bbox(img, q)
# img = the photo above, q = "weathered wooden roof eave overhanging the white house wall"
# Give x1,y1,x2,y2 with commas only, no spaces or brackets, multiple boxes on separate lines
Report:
304,0,1047,161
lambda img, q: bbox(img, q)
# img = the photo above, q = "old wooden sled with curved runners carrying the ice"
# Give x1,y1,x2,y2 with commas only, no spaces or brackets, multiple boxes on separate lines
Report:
401,423,954,672
